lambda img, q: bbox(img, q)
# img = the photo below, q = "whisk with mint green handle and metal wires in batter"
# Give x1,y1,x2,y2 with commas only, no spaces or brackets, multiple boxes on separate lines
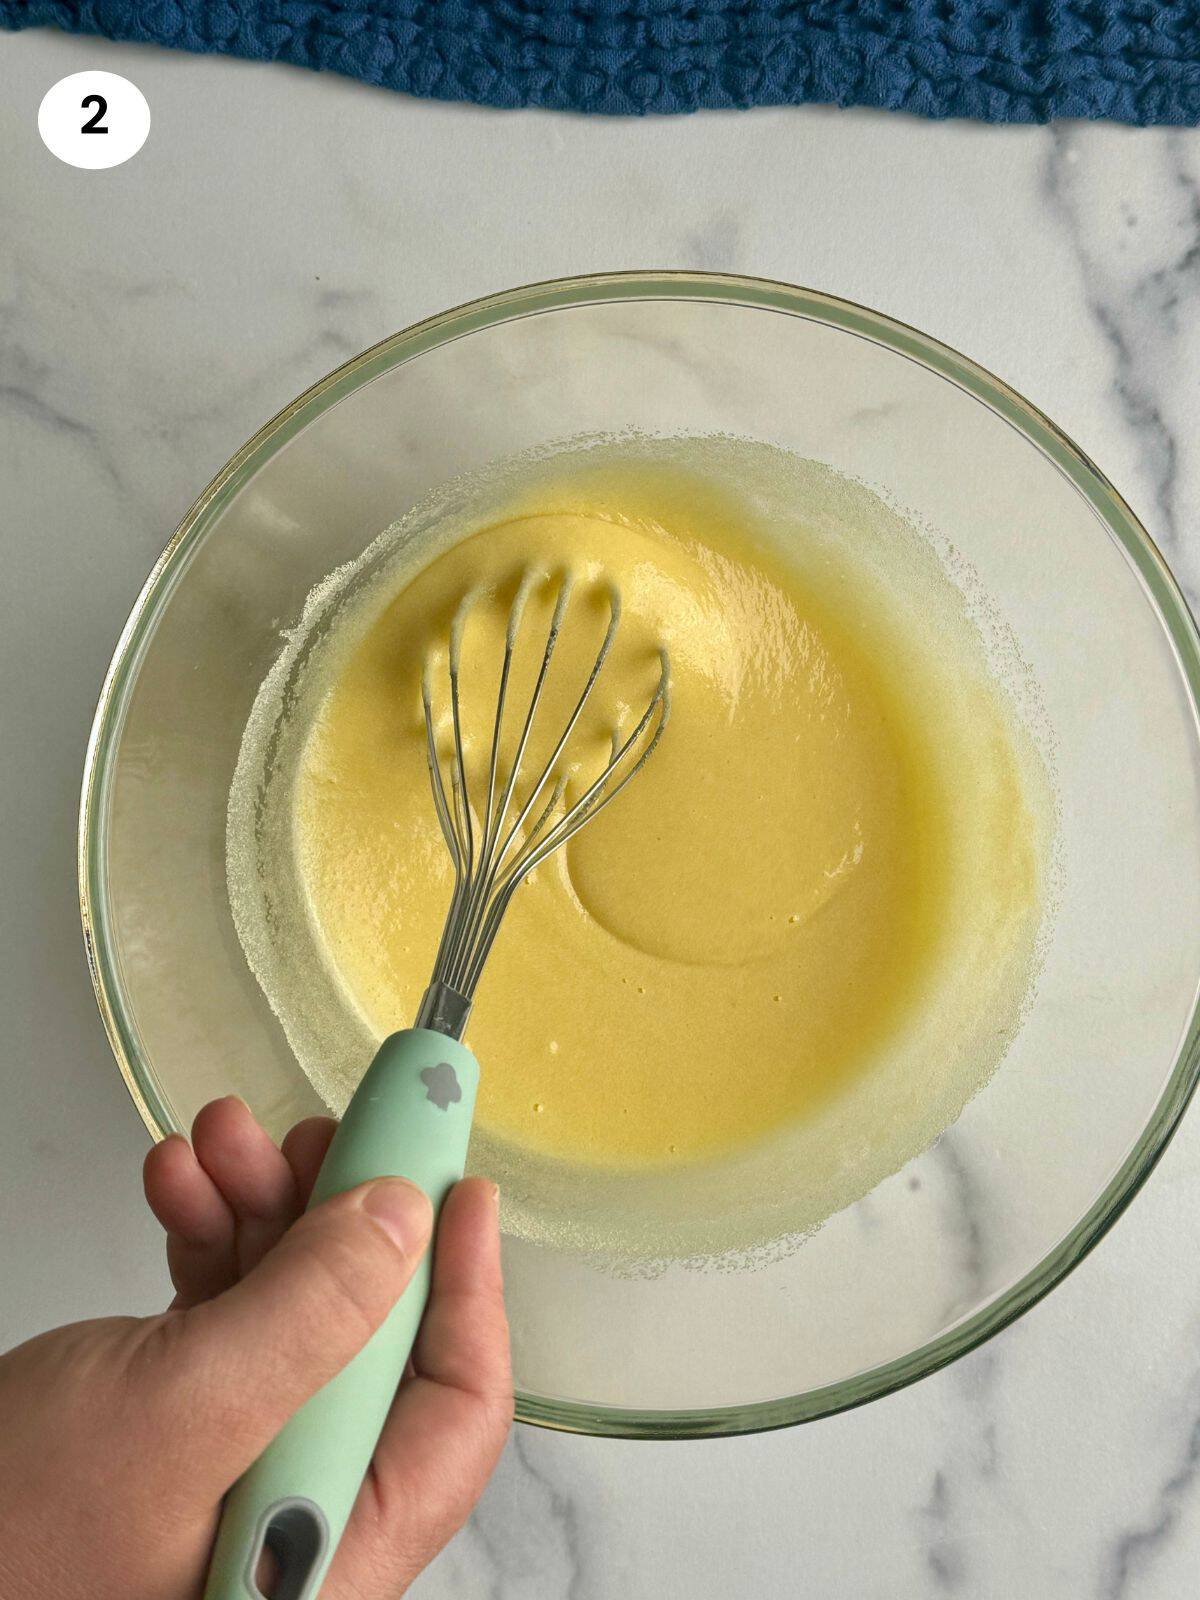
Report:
205,571,670,1600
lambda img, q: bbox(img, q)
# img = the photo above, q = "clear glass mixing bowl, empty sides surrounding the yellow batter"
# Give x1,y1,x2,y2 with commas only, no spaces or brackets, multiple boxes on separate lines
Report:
80,274,1200,1437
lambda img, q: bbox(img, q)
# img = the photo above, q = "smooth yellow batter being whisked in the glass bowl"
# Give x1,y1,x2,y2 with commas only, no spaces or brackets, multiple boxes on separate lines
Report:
293,461,1040,1177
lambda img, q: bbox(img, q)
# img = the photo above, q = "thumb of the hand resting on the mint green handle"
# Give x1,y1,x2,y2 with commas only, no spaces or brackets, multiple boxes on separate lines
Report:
149,1178,434,1493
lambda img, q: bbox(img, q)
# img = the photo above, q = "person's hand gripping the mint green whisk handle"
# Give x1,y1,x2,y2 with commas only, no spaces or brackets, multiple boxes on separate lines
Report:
0,1099,512,1600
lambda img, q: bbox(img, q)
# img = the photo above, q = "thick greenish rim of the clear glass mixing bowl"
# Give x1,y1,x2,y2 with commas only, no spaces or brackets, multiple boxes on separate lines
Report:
77,269,1200,1438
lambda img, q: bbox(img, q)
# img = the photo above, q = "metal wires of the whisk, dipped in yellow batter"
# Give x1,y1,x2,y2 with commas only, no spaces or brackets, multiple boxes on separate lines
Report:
418,571,670,1038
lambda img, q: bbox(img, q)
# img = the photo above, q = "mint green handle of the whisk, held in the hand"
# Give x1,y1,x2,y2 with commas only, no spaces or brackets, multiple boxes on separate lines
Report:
205,1027,478,1600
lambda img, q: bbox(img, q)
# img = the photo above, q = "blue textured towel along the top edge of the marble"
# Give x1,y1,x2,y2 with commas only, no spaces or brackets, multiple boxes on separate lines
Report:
0,0,1200,123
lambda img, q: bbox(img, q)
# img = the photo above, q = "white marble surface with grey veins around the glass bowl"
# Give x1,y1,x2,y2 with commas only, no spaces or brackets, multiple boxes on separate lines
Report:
0,34,1200,1600
